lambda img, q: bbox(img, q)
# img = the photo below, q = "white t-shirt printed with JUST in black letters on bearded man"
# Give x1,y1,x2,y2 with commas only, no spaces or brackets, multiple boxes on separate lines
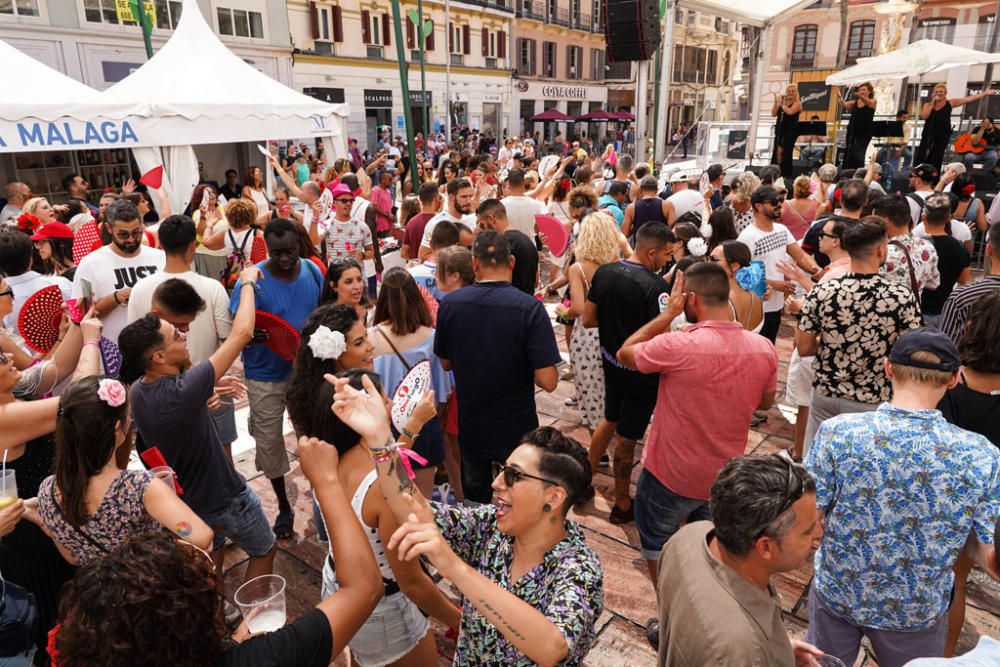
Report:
73,245,166,343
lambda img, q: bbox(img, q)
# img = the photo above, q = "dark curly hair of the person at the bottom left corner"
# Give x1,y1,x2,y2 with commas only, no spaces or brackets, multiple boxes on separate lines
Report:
55,531,229,667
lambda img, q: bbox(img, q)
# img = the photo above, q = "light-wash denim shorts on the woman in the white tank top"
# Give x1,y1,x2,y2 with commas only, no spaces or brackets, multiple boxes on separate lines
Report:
320,558,430,667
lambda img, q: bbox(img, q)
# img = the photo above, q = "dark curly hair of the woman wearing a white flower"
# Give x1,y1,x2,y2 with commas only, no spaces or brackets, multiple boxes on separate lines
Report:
286,304,361,436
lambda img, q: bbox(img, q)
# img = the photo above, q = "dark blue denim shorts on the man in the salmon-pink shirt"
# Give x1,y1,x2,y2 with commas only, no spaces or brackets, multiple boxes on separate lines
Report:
635,468,709,560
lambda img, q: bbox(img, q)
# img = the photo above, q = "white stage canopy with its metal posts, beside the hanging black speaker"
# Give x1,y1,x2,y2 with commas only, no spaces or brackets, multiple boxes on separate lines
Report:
652,0,815,160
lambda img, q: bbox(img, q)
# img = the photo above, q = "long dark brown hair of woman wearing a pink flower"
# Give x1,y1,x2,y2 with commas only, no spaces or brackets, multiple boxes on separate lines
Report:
55,375,128,528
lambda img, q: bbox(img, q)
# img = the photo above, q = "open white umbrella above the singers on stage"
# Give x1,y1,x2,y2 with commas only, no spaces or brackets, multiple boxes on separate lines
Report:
826,39,1000,86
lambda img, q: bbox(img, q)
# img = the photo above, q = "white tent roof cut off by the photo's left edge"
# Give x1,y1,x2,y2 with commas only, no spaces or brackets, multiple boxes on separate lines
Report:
0,40,129,122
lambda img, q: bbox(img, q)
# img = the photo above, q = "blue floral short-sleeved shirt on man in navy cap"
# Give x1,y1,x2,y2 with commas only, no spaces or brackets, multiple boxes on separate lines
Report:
805,404,1000,632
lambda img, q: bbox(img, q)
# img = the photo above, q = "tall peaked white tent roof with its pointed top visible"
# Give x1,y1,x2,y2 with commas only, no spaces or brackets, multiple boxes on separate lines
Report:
101,0,348,119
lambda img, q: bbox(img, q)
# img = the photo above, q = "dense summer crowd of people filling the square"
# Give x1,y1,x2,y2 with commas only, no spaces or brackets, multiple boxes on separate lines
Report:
0,126,1000,666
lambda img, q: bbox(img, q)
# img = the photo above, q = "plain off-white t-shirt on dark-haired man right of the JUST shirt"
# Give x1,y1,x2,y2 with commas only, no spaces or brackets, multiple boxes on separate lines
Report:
128,270,231,364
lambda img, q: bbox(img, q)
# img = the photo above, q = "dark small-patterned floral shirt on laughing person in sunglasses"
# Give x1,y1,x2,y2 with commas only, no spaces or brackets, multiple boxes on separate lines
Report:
431,503,604,667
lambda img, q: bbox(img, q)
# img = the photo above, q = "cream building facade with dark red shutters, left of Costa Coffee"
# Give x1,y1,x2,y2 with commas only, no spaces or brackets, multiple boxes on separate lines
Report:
288,0,514,147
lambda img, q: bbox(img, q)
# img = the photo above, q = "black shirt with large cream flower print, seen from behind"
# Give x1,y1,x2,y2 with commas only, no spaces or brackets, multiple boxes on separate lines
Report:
799,273,920,404
